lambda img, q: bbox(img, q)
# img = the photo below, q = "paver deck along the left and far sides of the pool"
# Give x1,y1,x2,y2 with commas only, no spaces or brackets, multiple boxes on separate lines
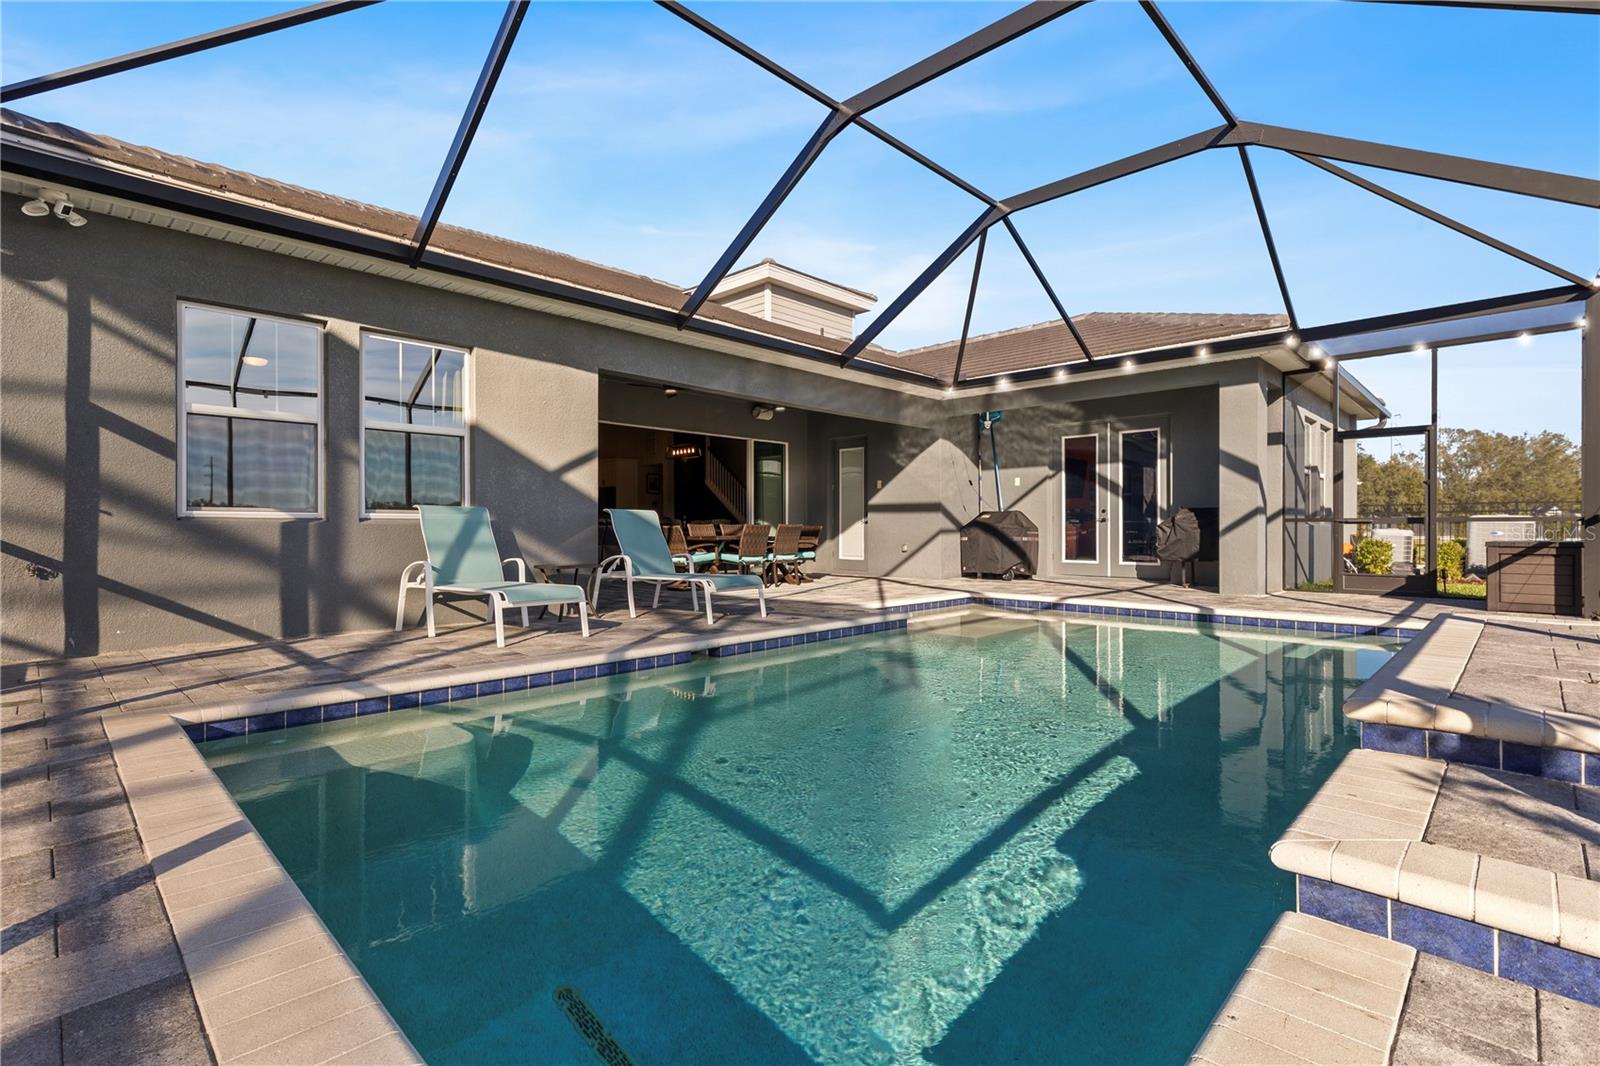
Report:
0,578,1600,1064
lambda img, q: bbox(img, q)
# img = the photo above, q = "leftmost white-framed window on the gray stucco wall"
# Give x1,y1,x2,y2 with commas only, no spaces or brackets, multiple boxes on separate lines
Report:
178,304,322,517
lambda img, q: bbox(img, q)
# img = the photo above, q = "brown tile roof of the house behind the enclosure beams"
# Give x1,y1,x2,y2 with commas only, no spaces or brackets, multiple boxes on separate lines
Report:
0,109,1288,379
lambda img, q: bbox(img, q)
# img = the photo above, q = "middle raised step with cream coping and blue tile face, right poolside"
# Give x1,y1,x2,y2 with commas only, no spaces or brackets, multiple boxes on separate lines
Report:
1270,749,1600,1005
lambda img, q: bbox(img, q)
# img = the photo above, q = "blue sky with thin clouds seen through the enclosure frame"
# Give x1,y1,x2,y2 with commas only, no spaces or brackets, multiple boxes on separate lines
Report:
0,0,1600,431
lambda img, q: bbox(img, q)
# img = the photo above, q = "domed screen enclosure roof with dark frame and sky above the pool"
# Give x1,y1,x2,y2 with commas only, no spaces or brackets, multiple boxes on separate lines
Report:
0,0,1600,391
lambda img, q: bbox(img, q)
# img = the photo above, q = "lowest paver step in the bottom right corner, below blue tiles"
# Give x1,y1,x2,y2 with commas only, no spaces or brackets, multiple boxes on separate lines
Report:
1190,914,1600,1066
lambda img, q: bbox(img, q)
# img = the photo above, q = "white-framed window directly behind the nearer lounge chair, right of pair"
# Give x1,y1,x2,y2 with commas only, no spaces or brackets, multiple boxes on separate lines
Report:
362,333,467,514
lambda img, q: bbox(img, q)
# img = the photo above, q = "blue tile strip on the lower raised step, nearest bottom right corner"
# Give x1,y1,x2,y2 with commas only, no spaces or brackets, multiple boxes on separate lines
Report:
1294,874,1600,1007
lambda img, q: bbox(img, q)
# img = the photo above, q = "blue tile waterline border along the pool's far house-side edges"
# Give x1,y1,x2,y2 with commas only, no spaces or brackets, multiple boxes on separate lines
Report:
184,594,1416,743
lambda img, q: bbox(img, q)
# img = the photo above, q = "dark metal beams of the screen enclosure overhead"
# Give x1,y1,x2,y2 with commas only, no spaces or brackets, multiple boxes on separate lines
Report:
0,0,1600,387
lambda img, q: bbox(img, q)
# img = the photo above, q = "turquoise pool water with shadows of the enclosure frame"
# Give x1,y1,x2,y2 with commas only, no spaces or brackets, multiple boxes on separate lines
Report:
202,613,1392,1064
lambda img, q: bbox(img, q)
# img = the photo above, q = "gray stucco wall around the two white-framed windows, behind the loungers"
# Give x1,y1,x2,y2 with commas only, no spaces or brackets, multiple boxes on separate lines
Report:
0,197,933,661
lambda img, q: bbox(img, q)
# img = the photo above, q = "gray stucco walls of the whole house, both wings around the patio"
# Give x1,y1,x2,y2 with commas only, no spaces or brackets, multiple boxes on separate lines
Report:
0,197,1282,659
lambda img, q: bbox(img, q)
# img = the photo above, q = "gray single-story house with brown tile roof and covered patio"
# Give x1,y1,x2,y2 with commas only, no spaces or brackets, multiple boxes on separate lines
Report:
0,112,1386,658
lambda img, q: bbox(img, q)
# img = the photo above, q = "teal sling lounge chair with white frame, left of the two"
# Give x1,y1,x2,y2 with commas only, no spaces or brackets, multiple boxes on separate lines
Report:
395,504,589,648
